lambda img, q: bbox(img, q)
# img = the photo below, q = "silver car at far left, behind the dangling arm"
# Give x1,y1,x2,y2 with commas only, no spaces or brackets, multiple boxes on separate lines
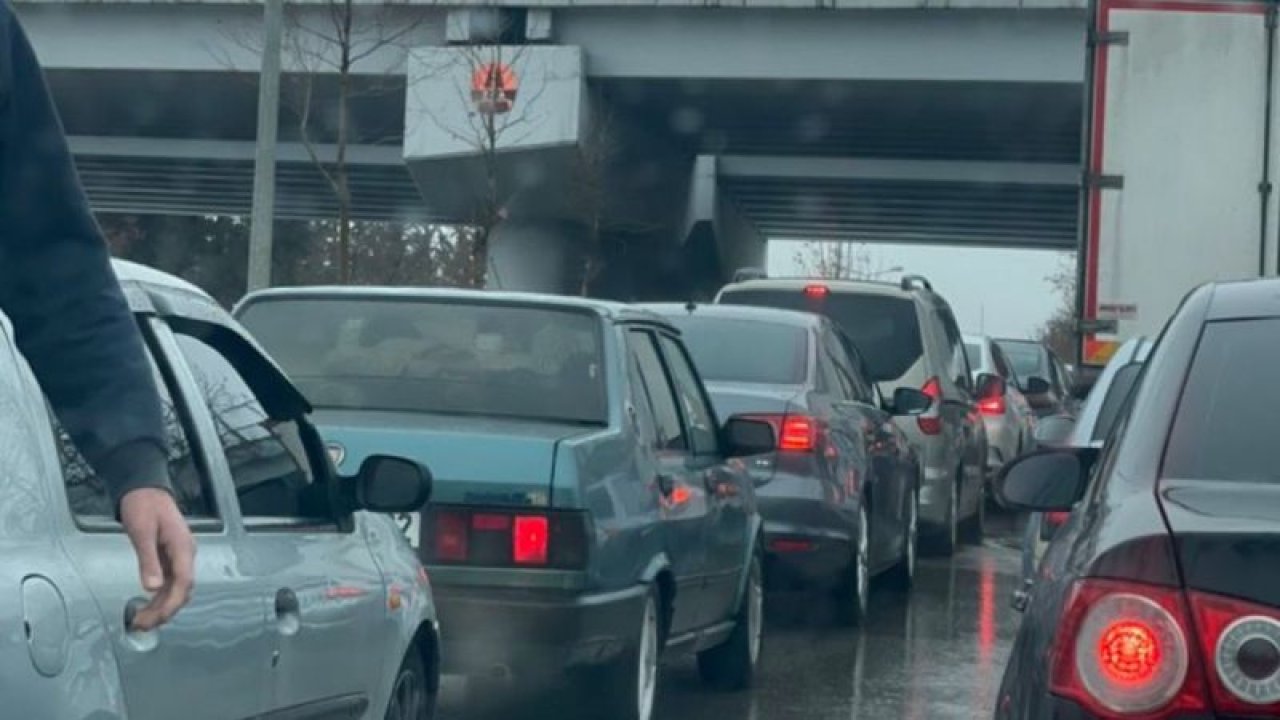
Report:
0,263,439,720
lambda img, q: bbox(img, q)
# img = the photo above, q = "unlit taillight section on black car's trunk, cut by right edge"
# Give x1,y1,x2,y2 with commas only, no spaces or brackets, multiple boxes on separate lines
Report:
1189,592,1280,717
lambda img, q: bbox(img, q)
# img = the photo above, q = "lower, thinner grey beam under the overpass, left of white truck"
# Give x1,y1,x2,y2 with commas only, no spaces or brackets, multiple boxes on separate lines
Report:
719,155,1080,187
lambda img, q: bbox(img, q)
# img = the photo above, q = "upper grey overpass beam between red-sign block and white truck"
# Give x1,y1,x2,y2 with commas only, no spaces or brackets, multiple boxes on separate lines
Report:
556,6,1087,82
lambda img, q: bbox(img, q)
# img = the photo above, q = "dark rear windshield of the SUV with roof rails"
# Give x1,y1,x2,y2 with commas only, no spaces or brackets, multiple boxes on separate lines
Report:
719,288,924,386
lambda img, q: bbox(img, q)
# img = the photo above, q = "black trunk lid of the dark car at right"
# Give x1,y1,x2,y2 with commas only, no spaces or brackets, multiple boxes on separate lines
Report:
1160,480,1280,607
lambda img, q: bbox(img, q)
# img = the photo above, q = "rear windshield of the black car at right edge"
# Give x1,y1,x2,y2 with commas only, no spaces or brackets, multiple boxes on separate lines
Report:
1164,319,1280,483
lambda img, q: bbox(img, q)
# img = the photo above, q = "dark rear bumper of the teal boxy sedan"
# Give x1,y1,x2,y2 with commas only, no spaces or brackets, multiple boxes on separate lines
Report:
433,568,646,678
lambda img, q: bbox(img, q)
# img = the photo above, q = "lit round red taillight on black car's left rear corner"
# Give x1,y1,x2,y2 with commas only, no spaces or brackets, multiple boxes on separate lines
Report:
1050,579,1208,720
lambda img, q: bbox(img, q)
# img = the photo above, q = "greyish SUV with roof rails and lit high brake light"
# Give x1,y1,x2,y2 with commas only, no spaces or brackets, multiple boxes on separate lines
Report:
716,275,1002,555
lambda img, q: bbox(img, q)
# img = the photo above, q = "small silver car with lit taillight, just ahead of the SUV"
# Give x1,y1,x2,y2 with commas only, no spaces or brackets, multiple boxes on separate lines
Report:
964,334,1036,475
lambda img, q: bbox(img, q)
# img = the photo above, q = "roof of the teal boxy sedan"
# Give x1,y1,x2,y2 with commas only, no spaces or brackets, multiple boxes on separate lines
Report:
233,286,667,324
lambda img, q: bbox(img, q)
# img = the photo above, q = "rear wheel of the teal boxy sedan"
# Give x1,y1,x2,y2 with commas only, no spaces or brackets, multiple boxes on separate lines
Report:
580,587,663,720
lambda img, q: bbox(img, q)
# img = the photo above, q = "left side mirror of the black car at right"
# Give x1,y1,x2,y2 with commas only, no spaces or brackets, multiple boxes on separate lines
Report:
995,448,1098,512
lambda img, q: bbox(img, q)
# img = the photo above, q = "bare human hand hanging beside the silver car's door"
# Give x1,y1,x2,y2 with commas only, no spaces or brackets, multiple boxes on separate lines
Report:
120,488,196,630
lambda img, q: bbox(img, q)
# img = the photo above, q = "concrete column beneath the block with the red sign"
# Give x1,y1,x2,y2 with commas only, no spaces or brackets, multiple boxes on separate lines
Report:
485,220,584,295
